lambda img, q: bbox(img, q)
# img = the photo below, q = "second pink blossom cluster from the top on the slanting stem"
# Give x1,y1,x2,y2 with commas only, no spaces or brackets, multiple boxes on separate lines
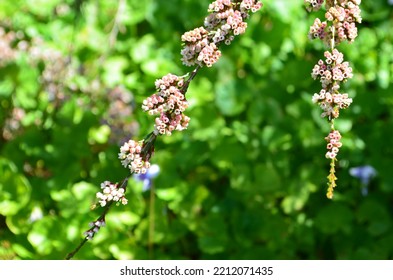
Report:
142,74,190,135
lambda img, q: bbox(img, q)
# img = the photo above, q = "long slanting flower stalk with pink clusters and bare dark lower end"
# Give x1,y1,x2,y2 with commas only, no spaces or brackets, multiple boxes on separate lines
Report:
66,0,262,259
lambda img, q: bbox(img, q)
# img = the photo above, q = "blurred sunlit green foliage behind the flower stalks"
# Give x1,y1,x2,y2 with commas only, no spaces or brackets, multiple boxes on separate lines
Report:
0,0,393,259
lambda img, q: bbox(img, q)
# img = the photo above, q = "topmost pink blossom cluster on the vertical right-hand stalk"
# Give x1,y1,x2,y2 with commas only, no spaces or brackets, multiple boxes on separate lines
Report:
305,0,362,45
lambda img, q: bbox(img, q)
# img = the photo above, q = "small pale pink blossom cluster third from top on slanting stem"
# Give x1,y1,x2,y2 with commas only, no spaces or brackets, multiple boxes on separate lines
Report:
119,140,150,174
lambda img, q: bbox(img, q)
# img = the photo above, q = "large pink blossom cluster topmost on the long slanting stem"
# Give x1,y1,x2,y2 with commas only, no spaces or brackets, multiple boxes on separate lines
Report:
181,0,262,67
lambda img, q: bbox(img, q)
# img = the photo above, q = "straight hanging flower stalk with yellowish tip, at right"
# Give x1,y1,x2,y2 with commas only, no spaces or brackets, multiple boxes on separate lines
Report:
304,0,362,199
